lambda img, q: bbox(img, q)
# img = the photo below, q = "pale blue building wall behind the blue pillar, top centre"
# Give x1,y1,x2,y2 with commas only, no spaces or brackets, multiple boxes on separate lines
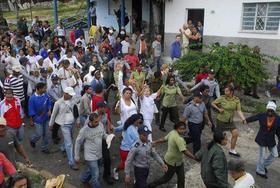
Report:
96,0,132,32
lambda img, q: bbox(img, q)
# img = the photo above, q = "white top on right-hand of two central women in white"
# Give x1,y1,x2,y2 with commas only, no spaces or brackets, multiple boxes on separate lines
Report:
140,93,157,120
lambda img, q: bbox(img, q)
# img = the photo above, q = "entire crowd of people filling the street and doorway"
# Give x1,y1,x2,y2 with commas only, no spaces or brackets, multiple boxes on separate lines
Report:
0,11,280,188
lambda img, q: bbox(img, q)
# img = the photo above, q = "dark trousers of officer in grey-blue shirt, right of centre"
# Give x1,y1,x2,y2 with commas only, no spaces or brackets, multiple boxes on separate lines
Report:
188,122,203,154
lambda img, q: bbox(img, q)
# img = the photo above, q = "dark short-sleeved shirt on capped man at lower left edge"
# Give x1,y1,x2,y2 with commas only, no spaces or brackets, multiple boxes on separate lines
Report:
0,132,20,165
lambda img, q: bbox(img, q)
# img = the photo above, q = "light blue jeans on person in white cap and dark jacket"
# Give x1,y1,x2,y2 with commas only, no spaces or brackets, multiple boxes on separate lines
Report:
256,146,278,174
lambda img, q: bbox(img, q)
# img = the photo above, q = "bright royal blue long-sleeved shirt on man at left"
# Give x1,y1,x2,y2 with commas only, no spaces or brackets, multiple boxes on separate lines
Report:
28,93,51,124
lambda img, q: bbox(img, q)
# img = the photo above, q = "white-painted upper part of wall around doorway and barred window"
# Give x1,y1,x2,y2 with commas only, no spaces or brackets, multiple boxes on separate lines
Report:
165,0,280,39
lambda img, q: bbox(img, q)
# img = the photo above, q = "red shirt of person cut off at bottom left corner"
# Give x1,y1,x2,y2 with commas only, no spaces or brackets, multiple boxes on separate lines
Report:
0,153,17,185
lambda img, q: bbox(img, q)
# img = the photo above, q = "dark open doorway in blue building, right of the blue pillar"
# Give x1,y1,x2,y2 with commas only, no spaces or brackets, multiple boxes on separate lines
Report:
132,0,142,33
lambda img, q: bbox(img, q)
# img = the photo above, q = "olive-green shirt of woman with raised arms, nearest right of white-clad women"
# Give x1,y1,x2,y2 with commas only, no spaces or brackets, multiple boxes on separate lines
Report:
162,85,181,108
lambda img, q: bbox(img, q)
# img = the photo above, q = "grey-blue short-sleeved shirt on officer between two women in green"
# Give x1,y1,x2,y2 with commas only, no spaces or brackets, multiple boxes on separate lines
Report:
183,101,206,124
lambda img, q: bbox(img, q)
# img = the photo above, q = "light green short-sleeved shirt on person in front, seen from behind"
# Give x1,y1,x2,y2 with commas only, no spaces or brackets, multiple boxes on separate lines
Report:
164,130,187,166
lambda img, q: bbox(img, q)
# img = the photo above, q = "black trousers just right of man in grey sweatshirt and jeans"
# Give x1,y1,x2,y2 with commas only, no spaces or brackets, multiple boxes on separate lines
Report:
102,140,111,178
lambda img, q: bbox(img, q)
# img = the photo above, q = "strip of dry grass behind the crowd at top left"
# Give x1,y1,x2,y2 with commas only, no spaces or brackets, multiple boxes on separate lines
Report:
4,0,87,24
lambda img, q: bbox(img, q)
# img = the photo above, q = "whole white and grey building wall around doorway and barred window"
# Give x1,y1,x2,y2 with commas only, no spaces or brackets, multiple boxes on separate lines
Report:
165,0,280,55
